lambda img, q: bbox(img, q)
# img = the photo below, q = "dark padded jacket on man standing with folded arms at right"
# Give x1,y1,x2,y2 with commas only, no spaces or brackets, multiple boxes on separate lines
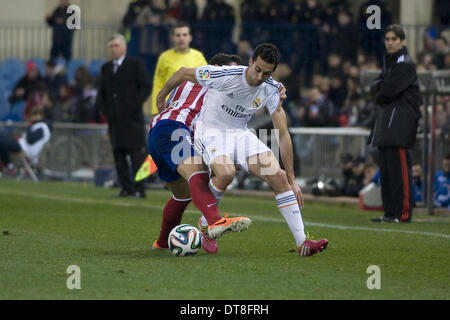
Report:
369,47,421,149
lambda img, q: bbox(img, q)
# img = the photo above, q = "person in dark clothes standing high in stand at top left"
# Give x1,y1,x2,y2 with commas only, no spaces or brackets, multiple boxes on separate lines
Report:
46,0,74,63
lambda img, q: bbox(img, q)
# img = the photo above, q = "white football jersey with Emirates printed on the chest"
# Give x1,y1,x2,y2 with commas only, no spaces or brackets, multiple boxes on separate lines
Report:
196,65,280,129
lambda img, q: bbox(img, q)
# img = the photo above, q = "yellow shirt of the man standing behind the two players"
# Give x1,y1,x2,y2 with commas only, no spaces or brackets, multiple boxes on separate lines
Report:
152,49,208,114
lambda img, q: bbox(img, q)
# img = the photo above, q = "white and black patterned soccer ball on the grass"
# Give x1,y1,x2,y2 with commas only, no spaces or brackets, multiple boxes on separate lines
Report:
169,224,202,257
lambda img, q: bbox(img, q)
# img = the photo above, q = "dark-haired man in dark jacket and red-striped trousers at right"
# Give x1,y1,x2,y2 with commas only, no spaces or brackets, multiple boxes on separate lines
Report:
369,25,421,222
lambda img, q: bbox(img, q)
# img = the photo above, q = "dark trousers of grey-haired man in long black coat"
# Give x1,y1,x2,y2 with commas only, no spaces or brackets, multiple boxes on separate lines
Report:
113,148,147,193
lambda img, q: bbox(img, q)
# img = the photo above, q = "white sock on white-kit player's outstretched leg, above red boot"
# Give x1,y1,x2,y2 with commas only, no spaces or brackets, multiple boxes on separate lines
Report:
275,190,306,246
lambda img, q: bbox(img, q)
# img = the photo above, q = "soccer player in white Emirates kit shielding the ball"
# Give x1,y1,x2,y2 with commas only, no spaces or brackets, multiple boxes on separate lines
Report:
157,43,328,256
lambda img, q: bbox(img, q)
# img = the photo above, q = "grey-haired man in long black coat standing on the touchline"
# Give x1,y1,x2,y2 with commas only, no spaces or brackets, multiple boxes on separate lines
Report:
96,34,151,198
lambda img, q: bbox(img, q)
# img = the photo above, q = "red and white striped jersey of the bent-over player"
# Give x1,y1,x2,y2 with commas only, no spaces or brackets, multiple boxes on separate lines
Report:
149,81,207,131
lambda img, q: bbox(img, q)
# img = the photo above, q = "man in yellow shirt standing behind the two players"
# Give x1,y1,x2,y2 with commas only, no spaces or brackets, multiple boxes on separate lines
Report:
152,22,208,114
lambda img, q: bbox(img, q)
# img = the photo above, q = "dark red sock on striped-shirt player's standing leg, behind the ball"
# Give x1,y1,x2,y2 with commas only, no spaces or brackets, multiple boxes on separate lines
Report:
158,197,191,248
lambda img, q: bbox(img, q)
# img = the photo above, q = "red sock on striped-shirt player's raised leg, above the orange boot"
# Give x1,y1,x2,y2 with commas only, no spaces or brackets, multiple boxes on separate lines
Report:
188,172,222,224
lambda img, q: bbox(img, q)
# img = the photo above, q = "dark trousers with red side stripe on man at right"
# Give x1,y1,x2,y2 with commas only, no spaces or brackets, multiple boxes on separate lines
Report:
378,147,413,221
